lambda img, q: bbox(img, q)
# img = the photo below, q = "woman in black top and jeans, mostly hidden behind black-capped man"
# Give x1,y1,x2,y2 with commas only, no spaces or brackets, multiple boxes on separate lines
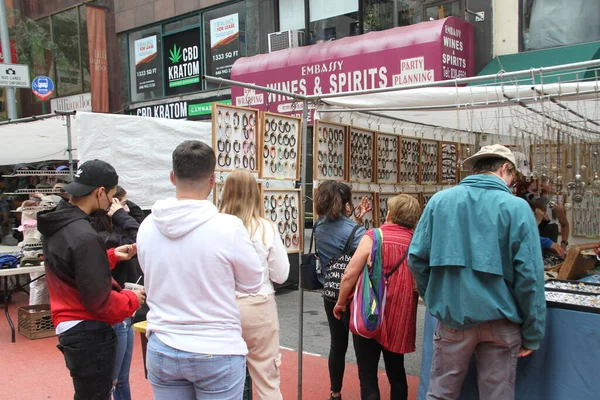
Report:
90,186,141,400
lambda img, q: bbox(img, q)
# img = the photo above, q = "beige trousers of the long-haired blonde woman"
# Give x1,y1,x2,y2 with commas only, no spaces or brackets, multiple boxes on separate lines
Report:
237,295,282,400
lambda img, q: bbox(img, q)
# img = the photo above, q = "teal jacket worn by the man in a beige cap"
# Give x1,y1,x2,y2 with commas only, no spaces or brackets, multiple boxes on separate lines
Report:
409,175,546,350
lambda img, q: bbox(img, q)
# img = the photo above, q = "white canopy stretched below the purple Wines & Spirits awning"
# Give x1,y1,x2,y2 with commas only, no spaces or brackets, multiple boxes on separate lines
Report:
317,81,600,142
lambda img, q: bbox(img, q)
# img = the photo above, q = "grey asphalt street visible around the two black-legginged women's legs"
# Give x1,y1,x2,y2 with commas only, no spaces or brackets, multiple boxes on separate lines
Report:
277,289,425,376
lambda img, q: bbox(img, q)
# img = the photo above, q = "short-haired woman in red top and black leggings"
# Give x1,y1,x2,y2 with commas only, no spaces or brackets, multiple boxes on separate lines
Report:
333,194,421,400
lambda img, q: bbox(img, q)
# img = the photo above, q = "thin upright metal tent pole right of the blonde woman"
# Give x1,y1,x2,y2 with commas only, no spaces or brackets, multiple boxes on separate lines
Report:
298,100,314,400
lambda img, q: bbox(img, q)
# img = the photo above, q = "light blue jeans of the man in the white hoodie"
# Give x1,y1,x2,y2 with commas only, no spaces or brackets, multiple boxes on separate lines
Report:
146,334,246,400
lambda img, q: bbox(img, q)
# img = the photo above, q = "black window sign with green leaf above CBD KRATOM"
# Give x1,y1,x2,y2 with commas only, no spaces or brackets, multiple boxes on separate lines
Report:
163,28,202,96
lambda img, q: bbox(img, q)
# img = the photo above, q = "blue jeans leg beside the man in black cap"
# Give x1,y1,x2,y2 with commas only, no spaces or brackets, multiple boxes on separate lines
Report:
112,318,134,400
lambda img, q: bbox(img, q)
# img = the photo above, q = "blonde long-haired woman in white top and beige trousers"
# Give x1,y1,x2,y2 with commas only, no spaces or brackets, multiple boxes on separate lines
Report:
220,170,290,400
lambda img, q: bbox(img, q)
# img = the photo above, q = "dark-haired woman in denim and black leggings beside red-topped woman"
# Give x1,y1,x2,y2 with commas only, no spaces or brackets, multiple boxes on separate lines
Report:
313,181,365,400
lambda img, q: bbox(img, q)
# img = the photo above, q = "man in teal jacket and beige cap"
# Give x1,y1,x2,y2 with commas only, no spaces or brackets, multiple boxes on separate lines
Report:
409,145,546,400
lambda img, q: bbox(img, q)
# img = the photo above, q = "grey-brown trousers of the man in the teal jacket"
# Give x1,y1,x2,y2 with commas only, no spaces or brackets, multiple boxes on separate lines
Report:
427,319,522,400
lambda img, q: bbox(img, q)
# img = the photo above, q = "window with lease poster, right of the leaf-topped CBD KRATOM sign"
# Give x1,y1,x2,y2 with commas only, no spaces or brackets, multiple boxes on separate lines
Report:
202,3,246,88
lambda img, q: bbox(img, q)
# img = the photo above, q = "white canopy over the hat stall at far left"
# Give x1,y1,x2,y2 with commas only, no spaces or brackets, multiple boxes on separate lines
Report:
0,116,77,165
